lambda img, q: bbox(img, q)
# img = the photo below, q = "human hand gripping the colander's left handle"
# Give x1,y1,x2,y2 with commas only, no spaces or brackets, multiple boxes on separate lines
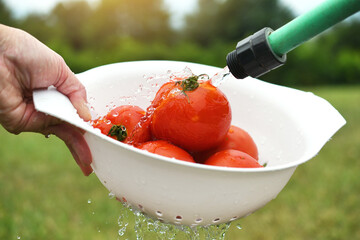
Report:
0,24,92,176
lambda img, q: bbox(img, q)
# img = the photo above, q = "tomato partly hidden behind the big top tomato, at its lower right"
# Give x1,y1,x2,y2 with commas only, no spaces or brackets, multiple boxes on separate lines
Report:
195,125,259,162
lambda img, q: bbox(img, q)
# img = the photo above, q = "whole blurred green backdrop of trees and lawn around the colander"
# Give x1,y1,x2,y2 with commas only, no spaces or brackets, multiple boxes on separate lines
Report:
0,0,360,240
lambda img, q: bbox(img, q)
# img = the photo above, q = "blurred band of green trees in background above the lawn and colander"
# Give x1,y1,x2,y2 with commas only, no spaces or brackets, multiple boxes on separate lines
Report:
0,0,360,86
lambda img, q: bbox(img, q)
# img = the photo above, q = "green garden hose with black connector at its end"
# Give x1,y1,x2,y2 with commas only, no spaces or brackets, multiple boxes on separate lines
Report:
226,0,360,79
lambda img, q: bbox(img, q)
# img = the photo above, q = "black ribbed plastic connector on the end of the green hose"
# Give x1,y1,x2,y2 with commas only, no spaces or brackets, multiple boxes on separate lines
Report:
226,27,286,79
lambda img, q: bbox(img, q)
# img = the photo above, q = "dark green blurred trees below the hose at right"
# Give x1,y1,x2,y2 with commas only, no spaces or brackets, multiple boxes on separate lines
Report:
262,20,360,85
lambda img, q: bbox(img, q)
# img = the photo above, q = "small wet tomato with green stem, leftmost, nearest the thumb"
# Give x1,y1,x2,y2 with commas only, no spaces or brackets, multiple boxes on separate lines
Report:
93,105,145,142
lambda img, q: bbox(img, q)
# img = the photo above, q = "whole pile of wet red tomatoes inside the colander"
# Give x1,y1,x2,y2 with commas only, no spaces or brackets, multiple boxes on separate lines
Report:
92,72,263,168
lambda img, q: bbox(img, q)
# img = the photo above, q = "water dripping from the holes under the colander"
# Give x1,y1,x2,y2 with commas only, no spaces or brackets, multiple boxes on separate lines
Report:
118,203,230,240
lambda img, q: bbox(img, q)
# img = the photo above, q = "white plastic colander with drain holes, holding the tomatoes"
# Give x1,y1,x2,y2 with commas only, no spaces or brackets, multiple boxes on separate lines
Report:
34,61,345,225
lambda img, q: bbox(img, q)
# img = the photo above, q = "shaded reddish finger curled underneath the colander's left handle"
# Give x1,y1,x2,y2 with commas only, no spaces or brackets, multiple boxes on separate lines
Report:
42,123,93,176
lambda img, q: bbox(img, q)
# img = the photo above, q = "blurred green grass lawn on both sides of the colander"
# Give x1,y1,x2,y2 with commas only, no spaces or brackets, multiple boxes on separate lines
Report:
0,86,360,240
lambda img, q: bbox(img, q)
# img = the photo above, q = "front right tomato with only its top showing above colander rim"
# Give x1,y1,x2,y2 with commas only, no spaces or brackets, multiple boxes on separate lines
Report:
204,149,263,168
